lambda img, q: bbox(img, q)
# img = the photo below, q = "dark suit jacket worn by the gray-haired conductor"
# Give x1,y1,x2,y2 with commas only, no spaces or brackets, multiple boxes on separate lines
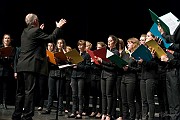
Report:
17,26,60,75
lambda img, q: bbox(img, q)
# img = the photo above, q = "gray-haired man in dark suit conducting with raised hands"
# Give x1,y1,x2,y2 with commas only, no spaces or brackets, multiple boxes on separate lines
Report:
12,13,66,120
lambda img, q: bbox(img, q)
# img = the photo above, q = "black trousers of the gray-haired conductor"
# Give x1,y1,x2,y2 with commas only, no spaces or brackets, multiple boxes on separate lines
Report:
12,72,39,120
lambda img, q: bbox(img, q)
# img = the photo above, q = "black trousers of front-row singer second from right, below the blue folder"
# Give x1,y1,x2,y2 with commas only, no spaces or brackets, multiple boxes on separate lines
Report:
140,79,155,120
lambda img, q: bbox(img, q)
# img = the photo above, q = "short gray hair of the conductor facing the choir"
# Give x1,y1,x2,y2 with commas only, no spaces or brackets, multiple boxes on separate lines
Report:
25,13,38,25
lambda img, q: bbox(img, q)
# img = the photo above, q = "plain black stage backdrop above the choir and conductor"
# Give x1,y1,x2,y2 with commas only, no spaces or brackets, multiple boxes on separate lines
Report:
0,0,180,48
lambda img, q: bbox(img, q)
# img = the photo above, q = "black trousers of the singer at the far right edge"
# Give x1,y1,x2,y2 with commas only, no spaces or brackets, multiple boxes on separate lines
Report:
166,68,180,120
